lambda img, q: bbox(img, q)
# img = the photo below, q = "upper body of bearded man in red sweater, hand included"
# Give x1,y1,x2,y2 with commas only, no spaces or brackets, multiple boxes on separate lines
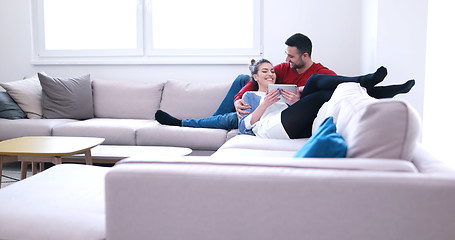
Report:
234,33,336,117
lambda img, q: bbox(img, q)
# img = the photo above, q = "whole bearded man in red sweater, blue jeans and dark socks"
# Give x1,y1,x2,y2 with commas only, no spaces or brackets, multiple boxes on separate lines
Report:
155,33,336,130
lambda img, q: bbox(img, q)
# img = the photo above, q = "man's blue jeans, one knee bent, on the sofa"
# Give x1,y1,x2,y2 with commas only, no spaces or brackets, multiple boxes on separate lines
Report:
182,74,250,130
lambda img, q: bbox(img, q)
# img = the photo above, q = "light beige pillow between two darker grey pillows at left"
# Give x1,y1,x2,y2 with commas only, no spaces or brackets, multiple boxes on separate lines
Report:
0,73,45,118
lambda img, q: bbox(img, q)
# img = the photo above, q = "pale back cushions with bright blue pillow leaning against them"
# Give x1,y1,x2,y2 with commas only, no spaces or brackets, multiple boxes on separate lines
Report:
302,83,421,161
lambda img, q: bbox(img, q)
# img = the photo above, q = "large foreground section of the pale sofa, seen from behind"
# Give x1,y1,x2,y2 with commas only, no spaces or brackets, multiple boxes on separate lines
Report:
0,77,455,240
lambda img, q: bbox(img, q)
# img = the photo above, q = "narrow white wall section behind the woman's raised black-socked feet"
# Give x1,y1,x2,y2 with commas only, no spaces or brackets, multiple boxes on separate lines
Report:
377,0,428,119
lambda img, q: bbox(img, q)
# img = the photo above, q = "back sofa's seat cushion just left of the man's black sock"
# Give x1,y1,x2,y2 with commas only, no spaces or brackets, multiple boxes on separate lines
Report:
53,118,154,145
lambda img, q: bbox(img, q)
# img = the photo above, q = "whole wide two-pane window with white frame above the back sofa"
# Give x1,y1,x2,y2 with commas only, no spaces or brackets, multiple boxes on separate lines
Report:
33,0,262,64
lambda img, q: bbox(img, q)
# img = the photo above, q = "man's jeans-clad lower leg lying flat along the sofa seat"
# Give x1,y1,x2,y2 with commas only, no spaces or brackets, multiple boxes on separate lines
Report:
182,112,239,130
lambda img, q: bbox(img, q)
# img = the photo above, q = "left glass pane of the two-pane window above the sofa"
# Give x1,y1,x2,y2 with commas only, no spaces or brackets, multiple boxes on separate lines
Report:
38,0,142,57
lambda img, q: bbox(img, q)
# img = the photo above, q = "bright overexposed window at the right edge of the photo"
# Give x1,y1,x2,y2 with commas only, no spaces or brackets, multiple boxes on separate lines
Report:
422,1,455,168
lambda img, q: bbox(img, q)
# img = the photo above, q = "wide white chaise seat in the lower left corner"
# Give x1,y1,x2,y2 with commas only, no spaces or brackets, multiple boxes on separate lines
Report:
0,164,110,239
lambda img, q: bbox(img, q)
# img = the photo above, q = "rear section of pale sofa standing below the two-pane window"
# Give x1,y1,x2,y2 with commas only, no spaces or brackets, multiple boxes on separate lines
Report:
0,76,237,155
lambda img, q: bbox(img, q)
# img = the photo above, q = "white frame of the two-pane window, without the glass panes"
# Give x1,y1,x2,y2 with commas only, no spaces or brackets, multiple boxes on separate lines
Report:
31,0,263,65
